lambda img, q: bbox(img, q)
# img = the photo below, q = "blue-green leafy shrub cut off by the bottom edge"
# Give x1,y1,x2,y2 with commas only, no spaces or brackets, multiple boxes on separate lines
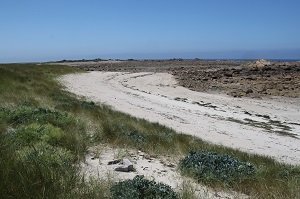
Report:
110,176,178,199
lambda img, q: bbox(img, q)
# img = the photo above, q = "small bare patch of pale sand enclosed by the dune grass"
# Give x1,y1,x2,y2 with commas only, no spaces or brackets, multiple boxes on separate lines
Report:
81,146,249,199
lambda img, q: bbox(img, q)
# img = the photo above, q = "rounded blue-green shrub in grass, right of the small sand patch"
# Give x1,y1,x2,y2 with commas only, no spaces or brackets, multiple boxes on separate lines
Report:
180,151,256,183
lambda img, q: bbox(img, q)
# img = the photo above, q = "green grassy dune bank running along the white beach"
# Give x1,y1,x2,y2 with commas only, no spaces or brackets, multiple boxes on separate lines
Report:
0,64,300,198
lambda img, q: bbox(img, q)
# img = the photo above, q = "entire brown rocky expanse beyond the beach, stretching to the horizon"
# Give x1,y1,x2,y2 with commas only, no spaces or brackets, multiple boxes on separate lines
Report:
58,60,300,98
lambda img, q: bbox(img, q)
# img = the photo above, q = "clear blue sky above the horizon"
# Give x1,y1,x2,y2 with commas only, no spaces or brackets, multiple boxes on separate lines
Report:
0,0,300,62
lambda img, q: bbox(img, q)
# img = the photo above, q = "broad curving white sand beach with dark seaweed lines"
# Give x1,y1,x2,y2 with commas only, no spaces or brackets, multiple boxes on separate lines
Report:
61,72,300,164
